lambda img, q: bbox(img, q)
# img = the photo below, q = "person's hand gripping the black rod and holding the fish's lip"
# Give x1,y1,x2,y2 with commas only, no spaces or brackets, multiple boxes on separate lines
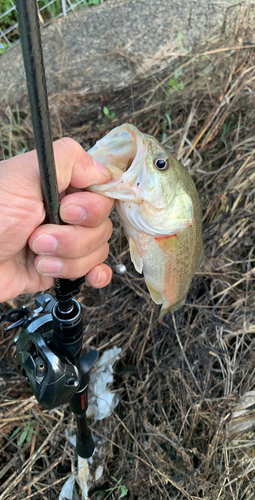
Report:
0,138,114,302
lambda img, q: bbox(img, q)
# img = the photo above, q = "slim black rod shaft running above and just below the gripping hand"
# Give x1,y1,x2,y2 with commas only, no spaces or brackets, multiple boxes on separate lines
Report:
16,0,72,310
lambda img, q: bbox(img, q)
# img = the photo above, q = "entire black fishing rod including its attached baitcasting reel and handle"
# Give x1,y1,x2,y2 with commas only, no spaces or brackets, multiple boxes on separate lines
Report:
2,0,98,458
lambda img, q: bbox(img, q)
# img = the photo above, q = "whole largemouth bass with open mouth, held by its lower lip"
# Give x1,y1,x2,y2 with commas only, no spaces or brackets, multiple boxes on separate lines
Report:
89,124,203,318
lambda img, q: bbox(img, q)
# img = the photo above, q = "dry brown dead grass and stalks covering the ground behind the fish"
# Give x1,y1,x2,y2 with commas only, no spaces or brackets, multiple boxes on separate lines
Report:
0,5,255,500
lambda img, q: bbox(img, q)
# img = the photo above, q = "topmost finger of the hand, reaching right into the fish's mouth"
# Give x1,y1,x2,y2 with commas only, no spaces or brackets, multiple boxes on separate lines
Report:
53,137,111,193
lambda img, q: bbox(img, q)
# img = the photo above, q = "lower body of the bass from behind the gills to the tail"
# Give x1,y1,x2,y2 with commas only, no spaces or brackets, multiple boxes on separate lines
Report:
121,217,202,318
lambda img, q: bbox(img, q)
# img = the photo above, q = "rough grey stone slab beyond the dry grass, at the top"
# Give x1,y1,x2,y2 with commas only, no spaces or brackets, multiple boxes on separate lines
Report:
0,0,241,102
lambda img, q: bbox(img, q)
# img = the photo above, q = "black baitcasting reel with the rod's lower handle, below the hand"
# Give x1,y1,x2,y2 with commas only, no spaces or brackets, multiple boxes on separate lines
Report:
1,278,98,458
